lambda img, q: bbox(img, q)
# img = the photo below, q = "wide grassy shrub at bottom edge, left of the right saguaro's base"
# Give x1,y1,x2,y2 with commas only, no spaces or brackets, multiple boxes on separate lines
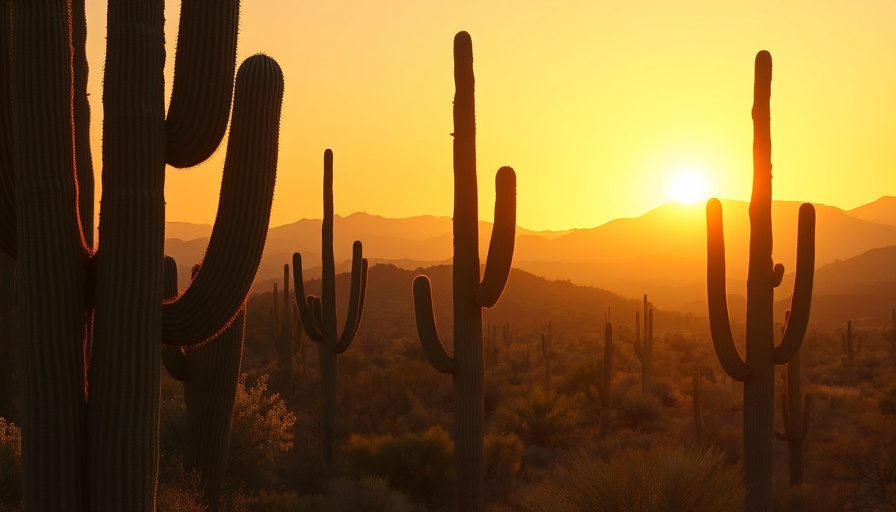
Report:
557,447,744,512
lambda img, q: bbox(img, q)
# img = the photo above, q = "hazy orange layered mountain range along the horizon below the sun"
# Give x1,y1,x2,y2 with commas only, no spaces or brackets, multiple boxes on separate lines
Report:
166,197,896,324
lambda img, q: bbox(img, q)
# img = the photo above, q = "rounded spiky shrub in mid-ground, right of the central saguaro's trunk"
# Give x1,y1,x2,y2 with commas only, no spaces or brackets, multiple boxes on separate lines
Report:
495,388,583,448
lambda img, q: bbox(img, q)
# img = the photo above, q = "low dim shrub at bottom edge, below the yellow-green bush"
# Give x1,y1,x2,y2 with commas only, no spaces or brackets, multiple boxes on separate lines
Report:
292,477,426,512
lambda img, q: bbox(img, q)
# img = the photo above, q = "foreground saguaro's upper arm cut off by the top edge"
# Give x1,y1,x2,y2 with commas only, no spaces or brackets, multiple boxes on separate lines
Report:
165,0,239,167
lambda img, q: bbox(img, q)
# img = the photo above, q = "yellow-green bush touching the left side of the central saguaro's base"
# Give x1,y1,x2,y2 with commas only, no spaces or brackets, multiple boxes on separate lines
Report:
343,427,454,510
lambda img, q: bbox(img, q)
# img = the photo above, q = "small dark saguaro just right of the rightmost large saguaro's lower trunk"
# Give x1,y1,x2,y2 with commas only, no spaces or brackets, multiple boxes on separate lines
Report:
775,342,812,487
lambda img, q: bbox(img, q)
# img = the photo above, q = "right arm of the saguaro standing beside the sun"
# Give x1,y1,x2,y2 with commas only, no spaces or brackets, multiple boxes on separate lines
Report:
774,203,815,364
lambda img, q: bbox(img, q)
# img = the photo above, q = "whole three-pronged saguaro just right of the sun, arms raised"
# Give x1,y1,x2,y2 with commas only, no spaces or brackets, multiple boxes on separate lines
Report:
706,51,815,511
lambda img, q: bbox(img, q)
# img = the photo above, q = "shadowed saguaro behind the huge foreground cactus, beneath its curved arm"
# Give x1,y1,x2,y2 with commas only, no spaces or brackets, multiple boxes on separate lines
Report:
162,257,246,512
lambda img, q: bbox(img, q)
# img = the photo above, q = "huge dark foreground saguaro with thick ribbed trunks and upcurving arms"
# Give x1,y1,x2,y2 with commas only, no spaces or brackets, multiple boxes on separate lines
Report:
0,0,283,510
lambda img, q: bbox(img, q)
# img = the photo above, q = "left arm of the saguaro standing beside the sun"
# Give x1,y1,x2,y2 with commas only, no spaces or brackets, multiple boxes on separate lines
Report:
706,199,753,382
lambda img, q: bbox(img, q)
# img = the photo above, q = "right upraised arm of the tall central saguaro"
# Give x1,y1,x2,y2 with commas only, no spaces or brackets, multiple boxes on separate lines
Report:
476,167,516,308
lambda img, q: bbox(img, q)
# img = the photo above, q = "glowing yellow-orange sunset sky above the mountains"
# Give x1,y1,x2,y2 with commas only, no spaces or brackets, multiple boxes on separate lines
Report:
88,0,896,230
